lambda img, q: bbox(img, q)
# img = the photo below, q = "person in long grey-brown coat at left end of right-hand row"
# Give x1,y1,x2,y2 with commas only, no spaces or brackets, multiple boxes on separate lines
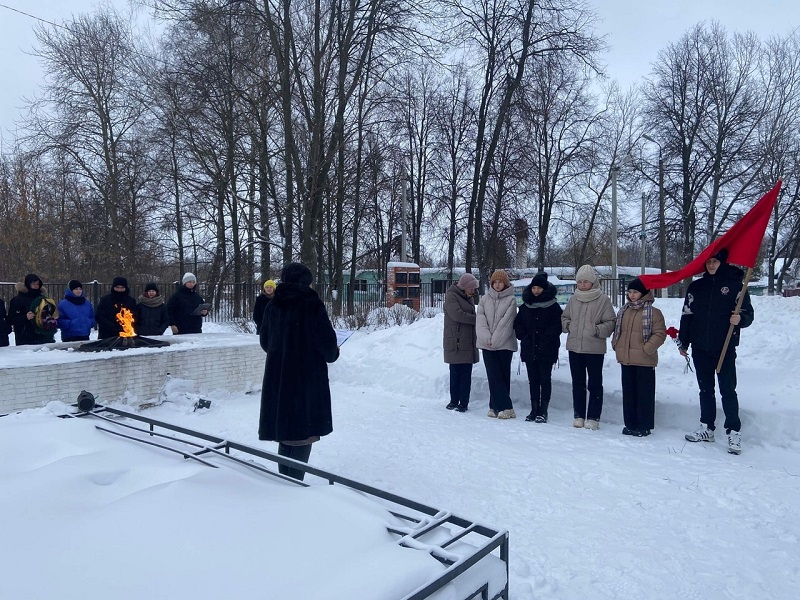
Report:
443,273,479,412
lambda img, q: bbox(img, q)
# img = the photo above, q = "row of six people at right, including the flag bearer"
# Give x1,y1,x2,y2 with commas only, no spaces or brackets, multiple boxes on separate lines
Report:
443,249,753,454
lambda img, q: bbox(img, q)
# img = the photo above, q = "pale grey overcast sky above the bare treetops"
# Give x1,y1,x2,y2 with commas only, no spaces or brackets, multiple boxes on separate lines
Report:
0,0,800,142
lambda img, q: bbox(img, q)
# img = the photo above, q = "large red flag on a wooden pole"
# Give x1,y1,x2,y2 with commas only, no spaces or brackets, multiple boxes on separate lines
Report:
639,181,782,290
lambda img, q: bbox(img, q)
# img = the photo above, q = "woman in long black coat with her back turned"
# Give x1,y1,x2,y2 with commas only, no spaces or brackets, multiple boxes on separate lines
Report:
258,263,339,481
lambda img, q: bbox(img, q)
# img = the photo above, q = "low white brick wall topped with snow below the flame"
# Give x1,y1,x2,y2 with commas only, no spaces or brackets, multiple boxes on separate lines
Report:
0,334,265,414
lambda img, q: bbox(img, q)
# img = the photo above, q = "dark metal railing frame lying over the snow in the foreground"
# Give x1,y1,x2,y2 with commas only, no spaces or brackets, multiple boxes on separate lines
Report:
63,405,509,600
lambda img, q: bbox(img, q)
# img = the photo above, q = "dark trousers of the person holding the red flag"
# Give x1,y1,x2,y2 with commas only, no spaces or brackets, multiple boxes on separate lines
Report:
692,346,742,431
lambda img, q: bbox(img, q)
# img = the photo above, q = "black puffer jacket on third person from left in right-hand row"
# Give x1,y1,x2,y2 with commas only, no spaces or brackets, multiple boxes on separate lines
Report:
514,282,562,363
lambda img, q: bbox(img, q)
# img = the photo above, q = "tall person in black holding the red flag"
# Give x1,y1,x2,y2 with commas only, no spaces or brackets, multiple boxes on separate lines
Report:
678,248,754,454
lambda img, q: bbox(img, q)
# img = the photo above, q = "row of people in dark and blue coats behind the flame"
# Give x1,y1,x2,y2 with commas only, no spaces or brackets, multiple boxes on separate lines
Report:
0,273,208,346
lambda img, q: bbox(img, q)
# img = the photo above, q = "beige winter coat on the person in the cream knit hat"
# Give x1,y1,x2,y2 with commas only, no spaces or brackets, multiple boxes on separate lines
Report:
561,282,617,354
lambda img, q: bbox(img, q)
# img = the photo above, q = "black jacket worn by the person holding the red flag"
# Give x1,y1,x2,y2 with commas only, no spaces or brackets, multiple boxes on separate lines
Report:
678,263,754,354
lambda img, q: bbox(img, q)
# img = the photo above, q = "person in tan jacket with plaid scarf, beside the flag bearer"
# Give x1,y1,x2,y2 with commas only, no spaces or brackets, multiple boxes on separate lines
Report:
611,277,667,437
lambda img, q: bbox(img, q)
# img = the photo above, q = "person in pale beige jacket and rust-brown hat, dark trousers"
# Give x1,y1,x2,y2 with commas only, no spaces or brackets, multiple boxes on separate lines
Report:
475,270,517,419
